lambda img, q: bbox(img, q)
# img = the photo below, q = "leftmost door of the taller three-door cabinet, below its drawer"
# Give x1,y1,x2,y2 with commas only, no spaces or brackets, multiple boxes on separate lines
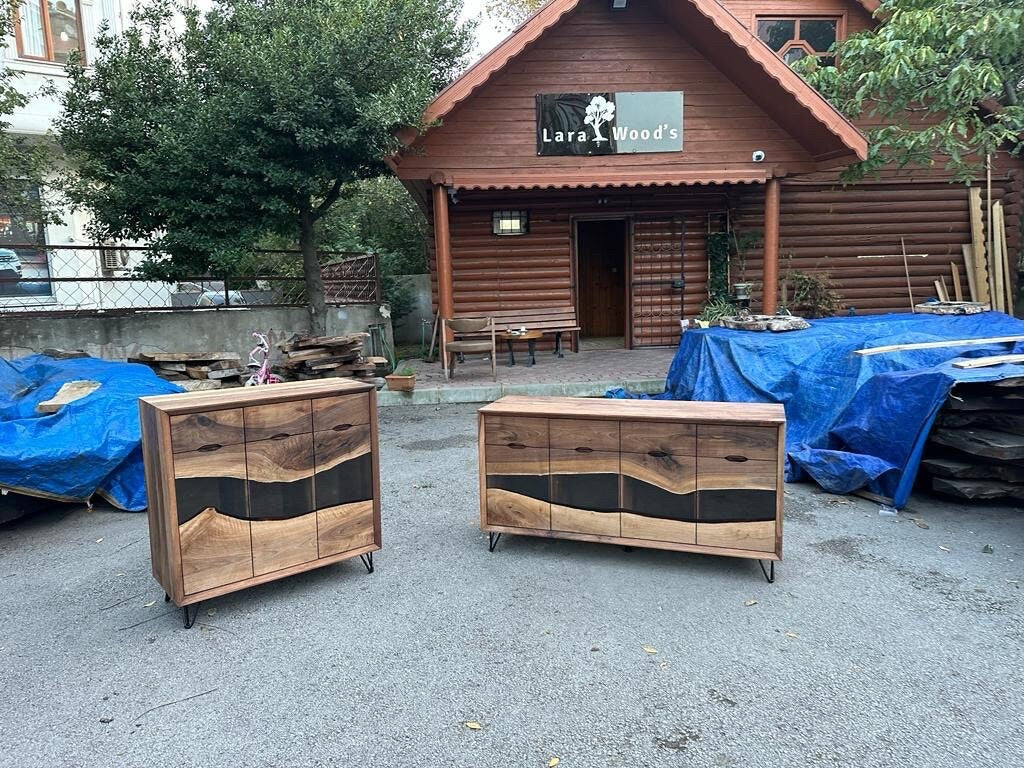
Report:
174,444,253,595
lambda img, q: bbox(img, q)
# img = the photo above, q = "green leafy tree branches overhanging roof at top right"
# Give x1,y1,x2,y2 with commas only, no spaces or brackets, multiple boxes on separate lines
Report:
798,0,1024,182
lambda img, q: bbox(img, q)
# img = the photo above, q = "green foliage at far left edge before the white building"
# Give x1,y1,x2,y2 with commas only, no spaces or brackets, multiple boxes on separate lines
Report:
0,2,59,230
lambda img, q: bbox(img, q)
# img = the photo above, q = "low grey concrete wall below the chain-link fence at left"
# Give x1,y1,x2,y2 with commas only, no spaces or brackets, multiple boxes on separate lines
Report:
0,304,393,362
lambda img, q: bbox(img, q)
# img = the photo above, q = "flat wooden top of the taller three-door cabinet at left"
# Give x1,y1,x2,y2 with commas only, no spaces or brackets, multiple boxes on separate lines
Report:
140,379,374,415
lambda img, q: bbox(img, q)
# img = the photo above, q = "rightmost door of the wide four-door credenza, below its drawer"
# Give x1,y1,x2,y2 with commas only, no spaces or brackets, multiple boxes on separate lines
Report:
697,456,778,552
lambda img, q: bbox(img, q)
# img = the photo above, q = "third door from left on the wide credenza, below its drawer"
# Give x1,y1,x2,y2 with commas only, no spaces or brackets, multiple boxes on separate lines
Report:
622,450,696,544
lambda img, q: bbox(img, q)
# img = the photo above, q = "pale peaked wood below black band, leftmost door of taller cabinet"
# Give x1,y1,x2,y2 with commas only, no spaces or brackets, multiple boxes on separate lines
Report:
178,508,253,595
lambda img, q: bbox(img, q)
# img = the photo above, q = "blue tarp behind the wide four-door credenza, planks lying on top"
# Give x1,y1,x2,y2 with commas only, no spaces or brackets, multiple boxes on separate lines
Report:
608,312,1024,508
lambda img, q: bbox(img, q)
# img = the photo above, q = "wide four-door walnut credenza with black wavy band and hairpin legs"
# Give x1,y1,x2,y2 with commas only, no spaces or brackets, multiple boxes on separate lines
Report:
478,396,785,582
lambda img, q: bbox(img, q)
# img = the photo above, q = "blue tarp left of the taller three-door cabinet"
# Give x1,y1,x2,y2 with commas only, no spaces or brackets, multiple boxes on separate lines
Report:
0,354,181,511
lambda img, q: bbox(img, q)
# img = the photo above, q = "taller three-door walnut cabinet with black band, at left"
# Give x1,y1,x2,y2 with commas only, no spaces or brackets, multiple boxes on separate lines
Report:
139,379,381,627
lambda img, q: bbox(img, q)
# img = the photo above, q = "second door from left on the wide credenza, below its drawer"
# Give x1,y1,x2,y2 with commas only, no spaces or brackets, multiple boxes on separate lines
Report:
551,450,621,536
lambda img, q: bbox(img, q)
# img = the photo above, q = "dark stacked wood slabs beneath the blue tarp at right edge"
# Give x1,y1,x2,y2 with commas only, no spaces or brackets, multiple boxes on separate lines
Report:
921,373,1024,501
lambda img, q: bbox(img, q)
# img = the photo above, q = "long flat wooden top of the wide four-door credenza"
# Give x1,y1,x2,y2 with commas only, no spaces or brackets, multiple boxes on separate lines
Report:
477,395,785,426
